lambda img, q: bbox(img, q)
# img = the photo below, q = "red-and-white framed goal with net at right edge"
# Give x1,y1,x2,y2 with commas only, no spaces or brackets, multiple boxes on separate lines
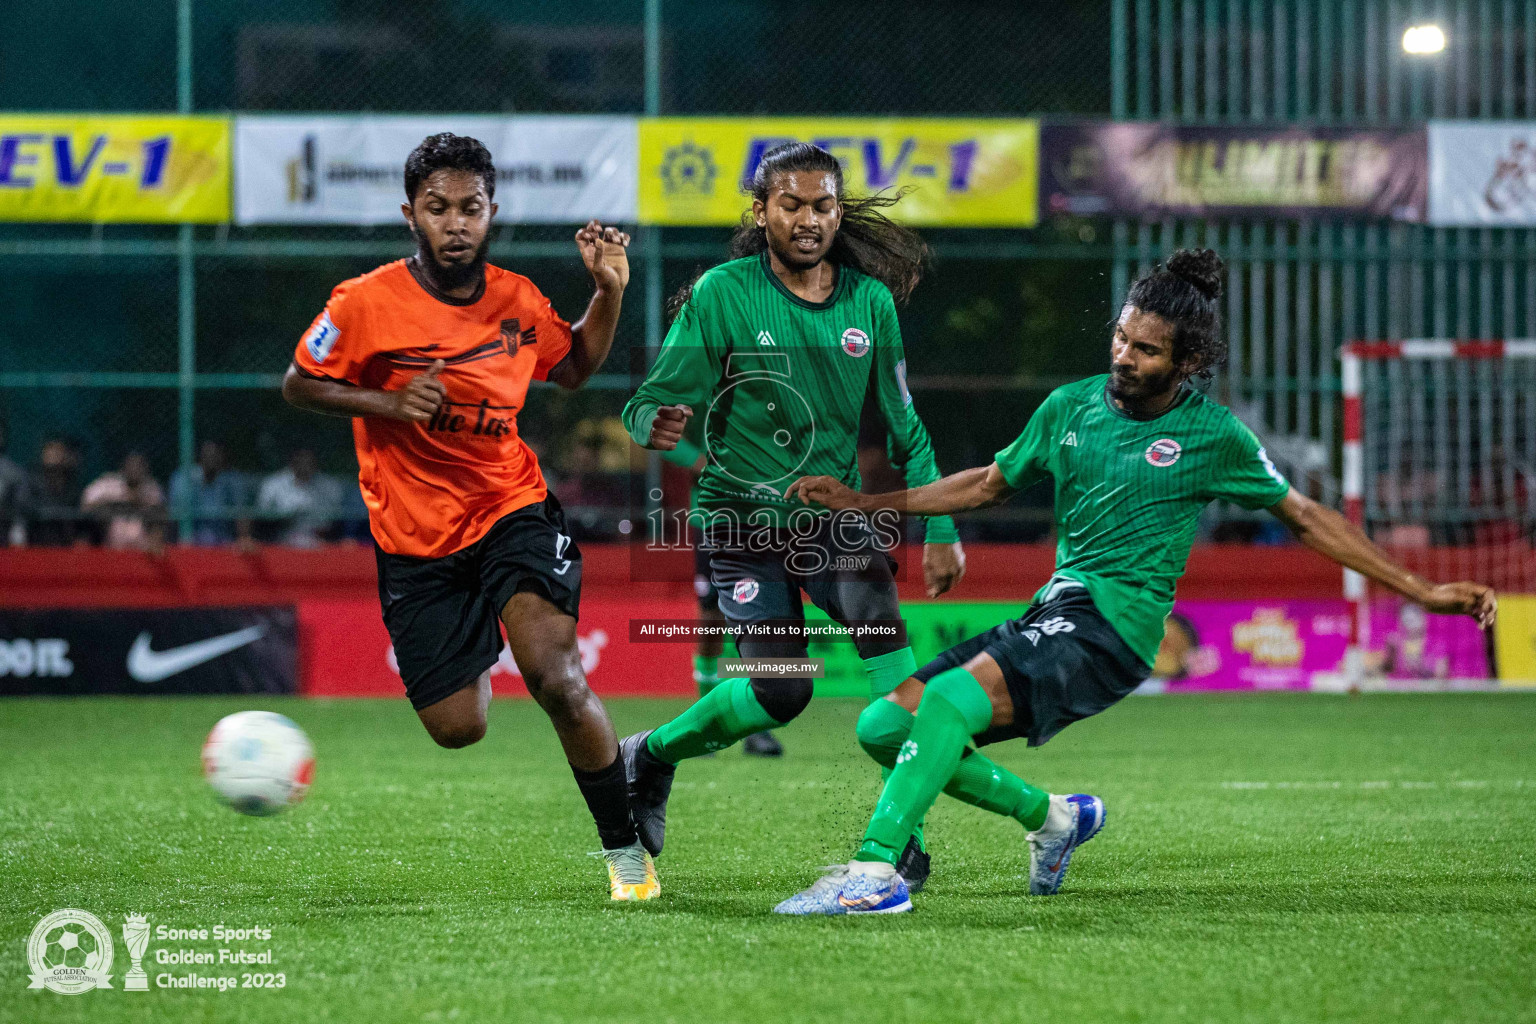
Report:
1342,338,1536,682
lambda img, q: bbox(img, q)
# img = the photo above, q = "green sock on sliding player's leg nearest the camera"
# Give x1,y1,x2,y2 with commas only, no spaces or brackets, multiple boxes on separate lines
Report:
854,668,992,864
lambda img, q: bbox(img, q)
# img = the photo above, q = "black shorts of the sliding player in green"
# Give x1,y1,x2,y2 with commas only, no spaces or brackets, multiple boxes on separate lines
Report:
917,585,1152,746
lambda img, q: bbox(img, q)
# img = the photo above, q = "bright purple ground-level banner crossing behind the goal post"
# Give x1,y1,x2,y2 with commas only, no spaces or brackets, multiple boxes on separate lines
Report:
1154,599,1488,689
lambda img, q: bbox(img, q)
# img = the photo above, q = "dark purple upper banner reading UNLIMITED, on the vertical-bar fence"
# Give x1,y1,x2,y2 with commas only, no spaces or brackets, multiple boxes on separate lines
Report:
1040,121,1428,221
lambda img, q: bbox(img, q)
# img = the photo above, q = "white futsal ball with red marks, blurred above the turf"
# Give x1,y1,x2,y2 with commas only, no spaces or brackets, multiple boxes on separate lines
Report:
203,711,315,815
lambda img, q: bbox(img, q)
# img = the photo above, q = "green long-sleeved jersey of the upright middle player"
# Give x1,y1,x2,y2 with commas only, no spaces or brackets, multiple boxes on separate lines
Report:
624,253,958,543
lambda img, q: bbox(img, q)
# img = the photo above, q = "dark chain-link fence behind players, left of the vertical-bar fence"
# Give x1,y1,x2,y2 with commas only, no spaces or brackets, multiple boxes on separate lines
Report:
0,0,1155,549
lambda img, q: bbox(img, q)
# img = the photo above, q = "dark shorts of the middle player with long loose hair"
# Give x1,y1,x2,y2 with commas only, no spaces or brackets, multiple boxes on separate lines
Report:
705,513,908,659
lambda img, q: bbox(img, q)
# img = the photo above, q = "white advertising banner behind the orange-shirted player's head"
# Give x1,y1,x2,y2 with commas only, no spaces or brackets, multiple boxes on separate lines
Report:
235,115,639,224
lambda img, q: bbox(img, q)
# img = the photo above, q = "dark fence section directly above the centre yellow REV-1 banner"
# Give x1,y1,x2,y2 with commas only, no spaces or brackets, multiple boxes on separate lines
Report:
662,0,1111,117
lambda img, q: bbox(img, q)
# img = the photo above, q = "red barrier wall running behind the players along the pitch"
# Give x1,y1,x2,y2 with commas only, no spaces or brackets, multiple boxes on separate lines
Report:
0,545,1339,697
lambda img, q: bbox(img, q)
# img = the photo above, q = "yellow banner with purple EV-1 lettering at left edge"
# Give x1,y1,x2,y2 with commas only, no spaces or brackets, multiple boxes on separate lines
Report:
0,114,229,224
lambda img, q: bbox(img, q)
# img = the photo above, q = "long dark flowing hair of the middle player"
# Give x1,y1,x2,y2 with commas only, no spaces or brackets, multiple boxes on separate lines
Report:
667,143,931,318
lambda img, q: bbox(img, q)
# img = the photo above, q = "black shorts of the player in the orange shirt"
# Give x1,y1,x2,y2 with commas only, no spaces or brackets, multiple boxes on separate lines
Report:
375,494,581,711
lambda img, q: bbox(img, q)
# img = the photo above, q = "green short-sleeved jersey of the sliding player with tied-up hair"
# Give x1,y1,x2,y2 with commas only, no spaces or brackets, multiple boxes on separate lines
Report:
997,375,1290,665
